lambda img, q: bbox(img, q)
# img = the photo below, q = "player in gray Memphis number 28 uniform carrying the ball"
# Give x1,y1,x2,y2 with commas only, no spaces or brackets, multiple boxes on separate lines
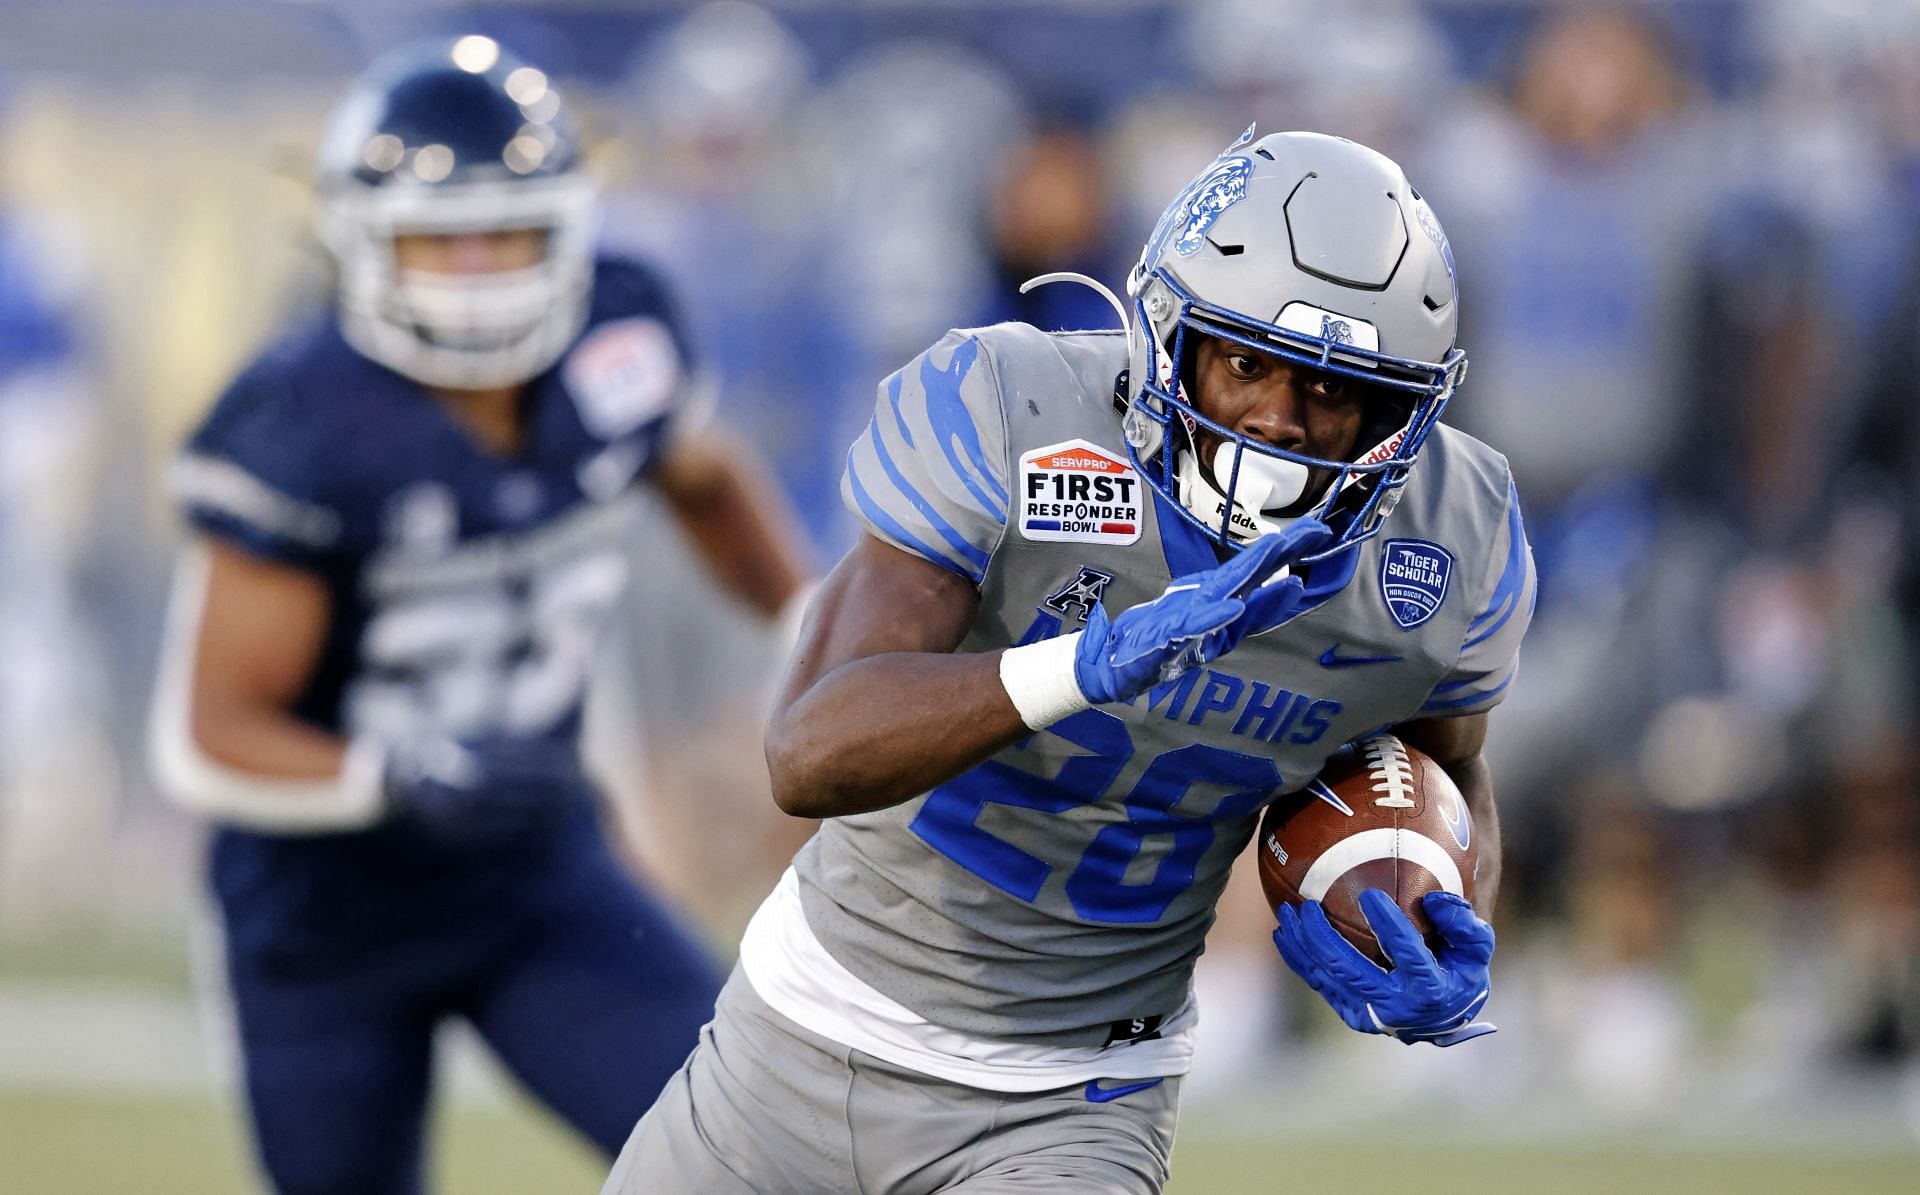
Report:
607,129,1534,1195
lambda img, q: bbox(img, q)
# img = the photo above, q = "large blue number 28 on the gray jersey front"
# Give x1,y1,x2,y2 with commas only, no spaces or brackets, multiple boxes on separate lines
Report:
910,709,1281,924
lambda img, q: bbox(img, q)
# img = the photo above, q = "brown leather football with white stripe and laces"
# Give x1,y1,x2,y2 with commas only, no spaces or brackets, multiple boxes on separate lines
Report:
1260,734,1478,963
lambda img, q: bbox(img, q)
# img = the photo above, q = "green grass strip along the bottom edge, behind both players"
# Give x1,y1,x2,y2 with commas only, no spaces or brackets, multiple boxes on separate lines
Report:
0,1093,1920,1195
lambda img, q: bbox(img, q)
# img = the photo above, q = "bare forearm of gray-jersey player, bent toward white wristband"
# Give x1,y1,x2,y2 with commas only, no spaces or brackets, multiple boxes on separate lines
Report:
766,651,1033,818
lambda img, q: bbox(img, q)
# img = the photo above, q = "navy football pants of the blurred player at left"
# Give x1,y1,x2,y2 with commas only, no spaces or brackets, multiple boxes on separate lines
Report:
227,841,720,1195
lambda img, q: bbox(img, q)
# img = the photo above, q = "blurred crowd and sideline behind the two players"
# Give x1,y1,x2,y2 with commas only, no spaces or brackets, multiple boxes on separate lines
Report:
0,0,1920,1191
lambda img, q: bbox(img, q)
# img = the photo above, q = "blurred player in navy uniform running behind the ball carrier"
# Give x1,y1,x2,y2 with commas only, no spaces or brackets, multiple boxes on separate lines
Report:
154,37,803,1195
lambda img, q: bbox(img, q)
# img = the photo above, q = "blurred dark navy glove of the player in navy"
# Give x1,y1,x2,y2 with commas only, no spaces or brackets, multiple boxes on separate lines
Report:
384,736,593,845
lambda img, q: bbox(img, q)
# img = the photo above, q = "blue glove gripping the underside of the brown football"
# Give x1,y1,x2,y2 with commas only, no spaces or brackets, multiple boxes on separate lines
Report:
1273,888,1494,1045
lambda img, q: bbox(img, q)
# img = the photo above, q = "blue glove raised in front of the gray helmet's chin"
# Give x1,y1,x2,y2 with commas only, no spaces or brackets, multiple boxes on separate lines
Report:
1073,519,1332,705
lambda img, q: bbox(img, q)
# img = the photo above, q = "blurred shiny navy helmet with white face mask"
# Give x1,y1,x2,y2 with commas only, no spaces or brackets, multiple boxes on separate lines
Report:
319,35,597,388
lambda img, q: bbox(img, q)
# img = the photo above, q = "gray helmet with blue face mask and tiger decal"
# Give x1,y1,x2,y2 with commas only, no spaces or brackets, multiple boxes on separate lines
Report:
1119,127,1467,559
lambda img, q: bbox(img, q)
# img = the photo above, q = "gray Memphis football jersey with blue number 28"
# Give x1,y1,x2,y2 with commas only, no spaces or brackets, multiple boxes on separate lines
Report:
795,325,1534,1045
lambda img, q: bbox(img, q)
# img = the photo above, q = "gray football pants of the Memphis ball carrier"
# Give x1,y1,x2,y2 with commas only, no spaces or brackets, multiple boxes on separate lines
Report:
601,966,1181,1195
